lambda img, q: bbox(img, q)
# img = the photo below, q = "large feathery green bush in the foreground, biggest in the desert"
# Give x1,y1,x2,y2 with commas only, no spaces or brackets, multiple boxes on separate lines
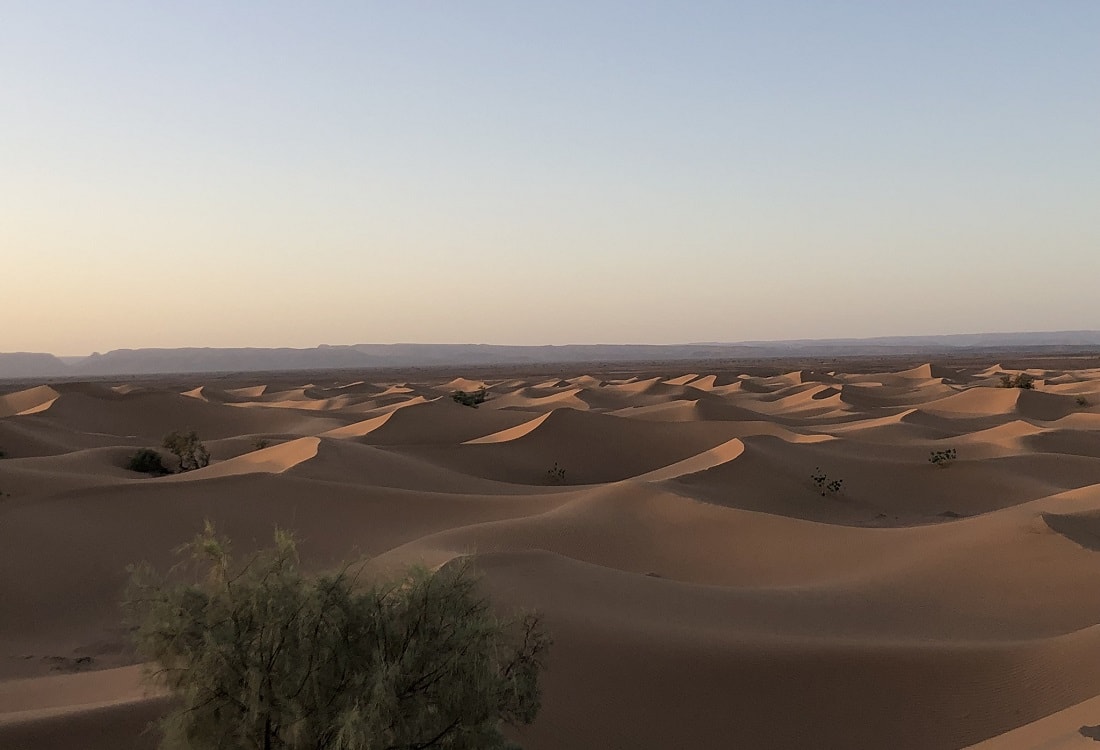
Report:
125,523,550,750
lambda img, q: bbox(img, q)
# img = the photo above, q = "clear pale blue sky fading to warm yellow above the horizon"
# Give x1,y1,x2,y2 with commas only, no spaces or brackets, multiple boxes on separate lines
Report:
0,0,1100,355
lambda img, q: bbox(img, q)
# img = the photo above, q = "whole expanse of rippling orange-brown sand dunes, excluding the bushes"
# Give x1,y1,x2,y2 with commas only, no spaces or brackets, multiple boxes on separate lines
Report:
0,363,1100,750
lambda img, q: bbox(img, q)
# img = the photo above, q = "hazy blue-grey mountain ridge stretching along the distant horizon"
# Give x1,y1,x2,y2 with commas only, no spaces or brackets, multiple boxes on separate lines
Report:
0,331,1100,379
